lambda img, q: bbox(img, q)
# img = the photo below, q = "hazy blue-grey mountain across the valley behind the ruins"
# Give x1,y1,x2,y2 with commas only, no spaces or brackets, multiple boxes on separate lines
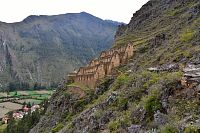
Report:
0,12,120,85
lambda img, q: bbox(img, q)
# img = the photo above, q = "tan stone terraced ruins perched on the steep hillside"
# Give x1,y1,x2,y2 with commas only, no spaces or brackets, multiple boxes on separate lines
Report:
68,43,134,88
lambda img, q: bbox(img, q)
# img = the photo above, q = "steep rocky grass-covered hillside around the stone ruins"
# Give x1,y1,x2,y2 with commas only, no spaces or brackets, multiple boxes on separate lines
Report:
30,0,200,133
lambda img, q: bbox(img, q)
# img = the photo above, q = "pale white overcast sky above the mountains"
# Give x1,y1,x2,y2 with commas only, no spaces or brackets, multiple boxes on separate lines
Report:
0,0,148,23
